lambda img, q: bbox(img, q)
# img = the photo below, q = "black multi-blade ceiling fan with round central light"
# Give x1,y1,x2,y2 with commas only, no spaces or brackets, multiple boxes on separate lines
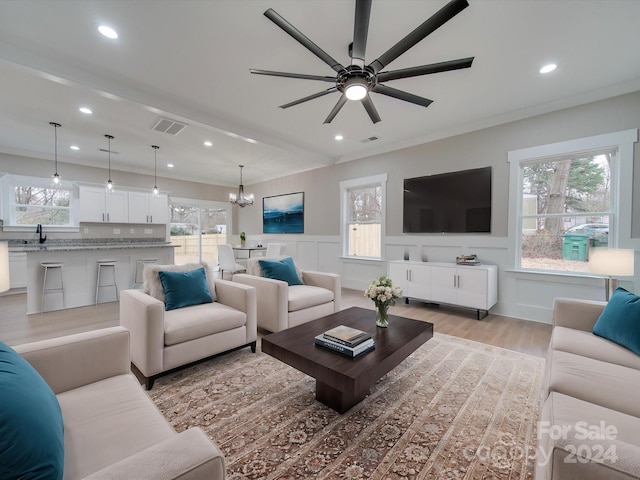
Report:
250,0,474,123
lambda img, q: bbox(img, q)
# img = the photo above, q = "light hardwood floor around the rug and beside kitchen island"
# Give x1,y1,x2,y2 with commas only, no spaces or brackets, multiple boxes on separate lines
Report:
0,288,551,357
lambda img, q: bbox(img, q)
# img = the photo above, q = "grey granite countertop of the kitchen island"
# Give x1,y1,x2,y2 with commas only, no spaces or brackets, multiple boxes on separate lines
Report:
9,239,177,253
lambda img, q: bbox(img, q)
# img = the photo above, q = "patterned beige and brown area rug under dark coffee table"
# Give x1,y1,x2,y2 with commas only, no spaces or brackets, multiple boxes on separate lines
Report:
149,333,544,480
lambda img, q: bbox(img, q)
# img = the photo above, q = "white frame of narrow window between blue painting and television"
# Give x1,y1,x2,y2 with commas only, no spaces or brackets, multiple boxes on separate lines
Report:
340,173,388,261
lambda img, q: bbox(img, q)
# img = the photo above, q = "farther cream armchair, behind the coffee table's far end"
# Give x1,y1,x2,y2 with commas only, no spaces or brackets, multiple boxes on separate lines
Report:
233,256,342,332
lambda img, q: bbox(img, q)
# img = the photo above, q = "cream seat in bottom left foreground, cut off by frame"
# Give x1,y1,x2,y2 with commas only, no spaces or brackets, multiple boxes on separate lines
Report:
14,327,225,480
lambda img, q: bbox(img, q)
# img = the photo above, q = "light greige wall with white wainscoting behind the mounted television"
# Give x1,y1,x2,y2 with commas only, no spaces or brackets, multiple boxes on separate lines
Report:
237,92,640,322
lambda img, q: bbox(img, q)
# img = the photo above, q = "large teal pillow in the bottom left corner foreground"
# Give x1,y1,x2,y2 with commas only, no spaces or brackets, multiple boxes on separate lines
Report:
0,342,64,480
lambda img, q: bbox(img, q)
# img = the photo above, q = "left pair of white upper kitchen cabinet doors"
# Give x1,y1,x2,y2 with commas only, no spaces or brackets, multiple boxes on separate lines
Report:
78,185,129,223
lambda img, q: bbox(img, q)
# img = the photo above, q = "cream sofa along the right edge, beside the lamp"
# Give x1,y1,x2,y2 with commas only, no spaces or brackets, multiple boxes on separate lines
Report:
535,298,640,480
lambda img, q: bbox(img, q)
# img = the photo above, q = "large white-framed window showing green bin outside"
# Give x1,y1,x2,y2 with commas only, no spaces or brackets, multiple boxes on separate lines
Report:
509,130,637,272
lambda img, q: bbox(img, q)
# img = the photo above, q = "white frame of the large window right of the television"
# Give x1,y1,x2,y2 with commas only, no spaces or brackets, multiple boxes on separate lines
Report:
507,129,638,275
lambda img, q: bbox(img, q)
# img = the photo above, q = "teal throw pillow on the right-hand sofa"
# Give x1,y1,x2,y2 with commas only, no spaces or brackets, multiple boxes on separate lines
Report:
593,288,640,355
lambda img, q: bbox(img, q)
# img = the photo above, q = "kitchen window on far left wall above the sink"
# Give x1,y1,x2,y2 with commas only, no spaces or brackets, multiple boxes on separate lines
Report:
3,175,73,227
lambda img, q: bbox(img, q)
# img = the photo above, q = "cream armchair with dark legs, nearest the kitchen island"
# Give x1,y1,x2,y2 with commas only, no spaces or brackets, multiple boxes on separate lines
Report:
120,264,258,389
